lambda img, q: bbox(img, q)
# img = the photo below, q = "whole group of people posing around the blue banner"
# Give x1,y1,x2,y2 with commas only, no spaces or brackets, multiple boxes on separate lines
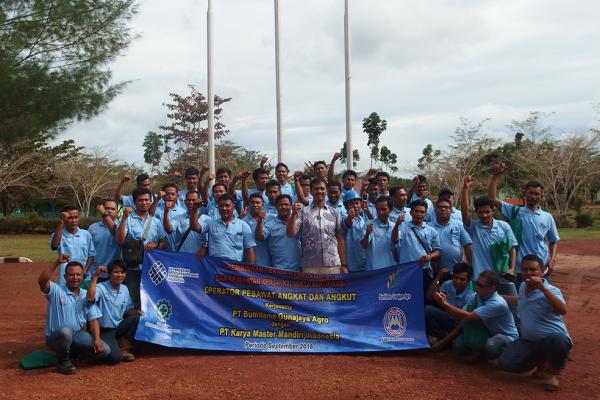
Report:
39,153,572,390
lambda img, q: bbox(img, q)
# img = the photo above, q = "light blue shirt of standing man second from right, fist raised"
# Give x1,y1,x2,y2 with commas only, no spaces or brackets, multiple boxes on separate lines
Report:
465,219,517,280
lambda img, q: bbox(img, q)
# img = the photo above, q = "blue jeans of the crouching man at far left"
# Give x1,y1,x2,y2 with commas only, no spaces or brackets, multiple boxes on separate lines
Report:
46,326,110,361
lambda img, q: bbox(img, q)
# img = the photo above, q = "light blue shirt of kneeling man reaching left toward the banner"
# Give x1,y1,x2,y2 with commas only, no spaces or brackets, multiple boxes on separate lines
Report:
469,292,519,340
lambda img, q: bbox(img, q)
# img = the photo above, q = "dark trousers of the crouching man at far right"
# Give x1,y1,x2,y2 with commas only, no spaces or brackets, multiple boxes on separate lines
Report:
498,332,573,372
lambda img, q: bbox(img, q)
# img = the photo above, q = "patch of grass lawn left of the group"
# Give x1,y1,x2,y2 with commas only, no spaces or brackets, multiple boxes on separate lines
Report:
0,235,56,261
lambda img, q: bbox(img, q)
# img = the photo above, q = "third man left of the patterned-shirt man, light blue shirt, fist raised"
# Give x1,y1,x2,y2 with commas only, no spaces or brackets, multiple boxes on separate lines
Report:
190,194,256,264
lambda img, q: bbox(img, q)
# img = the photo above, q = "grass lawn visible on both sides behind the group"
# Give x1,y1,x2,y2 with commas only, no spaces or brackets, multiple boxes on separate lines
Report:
0,228,600,261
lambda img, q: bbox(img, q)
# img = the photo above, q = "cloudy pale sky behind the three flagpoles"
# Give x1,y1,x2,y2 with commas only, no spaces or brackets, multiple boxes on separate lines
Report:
60,0,600,175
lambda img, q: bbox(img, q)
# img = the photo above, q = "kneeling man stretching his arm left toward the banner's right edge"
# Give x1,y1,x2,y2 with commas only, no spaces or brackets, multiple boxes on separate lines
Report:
434,270,519,362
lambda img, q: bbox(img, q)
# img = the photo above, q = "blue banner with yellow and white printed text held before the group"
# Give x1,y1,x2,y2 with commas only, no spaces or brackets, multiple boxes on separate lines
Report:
136,250,429,352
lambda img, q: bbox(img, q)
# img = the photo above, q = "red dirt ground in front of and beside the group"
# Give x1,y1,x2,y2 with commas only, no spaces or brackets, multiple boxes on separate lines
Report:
0,241,600,400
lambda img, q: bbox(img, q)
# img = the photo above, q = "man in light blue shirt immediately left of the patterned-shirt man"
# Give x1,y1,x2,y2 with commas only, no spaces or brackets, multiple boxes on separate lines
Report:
256,194,302,272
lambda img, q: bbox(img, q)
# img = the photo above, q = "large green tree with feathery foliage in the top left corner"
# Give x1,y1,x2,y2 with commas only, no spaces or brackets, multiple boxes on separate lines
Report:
0,0,135,146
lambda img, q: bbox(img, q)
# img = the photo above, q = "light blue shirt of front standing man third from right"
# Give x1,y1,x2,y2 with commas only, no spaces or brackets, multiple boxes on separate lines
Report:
430,217,473,273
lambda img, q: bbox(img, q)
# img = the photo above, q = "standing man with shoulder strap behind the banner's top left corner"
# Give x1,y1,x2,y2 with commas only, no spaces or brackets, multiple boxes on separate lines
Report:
115,188,166,309
